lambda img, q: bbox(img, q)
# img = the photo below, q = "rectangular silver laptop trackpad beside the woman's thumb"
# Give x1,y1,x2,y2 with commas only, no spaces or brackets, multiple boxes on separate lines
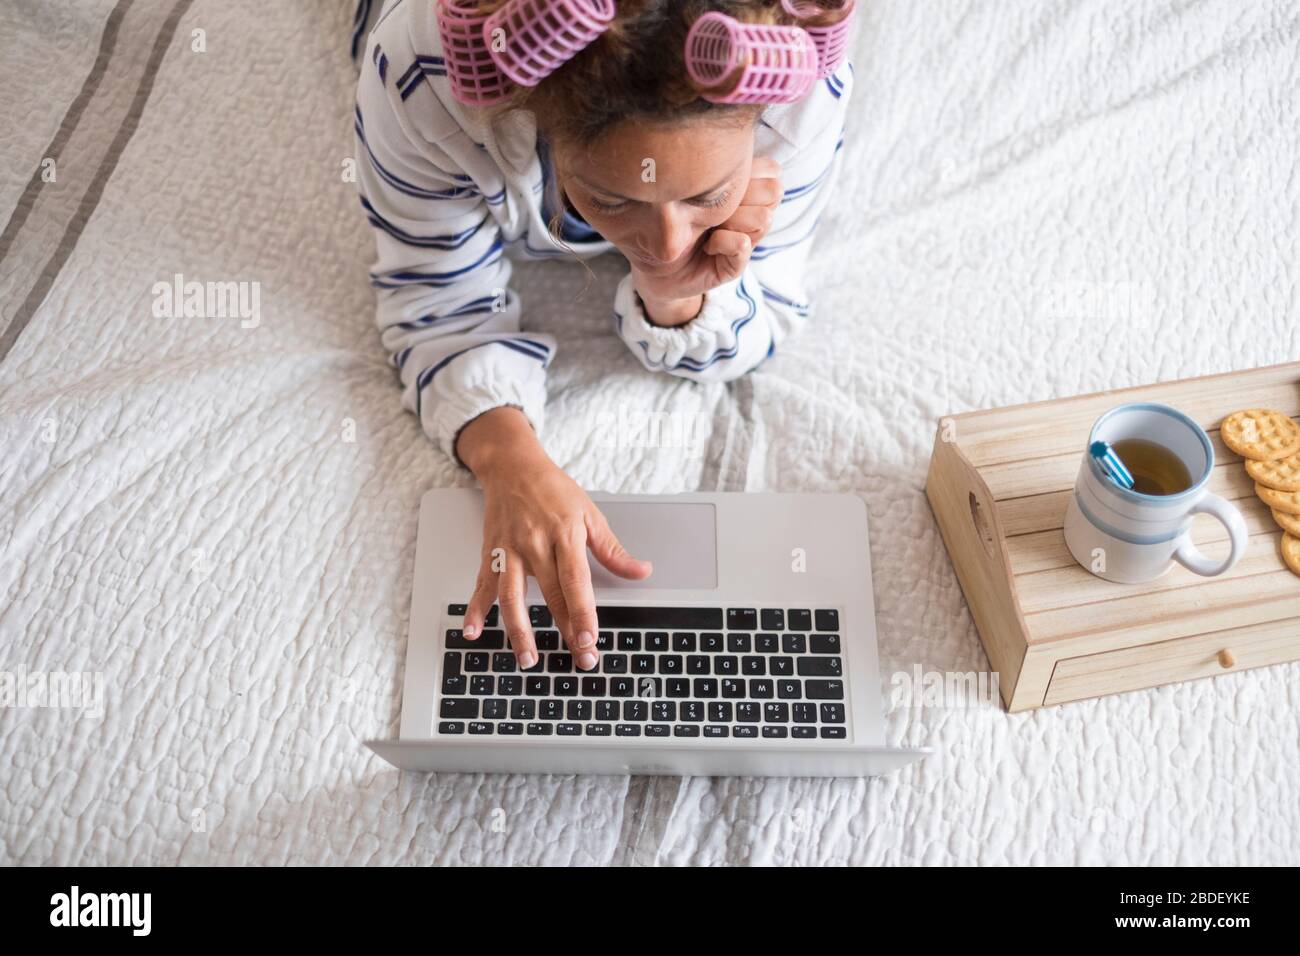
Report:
588,501,718,589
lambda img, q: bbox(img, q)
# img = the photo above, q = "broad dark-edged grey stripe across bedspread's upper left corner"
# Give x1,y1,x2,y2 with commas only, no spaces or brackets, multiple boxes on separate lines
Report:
0,0,194,360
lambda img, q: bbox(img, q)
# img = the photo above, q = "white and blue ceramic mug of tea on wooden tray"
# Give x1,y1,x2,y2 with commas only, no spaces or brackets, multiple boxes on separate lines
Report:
1065,402,1249,584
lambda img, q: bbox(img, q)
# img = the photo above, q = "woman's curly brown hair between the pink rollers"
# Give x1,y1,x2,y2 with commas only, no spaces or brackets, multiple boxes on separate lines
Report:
460,0,846,146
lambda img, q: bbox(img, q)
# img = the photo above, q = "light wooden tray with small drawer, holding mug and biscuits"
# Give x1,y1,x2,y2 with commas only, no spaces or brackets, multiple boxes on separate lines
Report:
926,363,1300,711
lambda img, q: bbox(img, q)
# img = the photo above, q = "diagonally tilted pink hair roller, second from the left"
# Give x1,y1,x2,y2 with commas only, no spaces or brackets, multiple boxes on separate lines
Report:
484,0,615,86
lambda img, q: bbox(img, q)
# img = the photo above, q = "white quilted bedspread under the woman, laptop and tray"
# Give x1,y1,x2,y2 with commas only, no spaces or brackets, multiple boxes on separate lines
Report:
0,0,1300,865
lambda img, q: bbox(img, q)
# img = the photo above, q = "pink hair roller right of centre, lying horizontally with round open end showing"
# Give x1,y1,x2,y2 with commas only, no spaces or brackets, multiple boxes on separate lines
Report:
686,10,818,103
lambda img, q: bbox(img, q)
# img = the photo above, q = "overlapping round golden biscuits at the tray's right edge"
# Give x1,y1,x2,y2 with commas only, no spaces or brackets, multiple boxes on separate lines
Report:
1219,408,1300,575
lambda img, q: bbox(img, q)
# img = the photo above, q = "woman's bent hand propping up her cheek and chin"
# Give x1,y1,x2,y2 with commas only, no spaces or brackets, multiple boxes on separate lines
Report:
632,156,781,325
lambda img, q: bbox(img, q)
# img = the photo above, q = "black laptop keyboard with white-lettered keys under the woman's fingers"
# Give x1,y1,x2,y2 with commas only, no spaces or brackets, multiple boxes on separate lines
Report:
437,604,848,740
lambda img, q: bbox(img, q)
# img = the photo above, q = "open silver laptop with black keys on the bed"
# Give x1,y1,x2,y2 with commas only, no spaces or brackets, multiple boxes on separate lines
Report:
367,489,928,777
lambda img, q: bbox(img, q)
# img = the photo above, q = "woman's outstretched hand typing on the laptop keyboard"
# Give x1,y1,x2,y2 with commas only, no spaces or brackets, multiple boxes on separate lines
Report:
456,407,653,670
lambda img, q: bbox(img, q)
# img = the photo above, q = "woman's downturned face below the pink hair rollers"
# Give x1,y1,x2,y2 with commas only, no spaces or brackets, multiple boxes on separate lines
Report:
555,120,754,276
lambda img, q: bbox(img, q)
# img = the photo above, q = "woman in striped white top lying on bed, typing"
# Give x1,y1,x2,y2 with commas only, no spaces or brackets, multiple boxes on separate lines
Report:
356,0,853,670
